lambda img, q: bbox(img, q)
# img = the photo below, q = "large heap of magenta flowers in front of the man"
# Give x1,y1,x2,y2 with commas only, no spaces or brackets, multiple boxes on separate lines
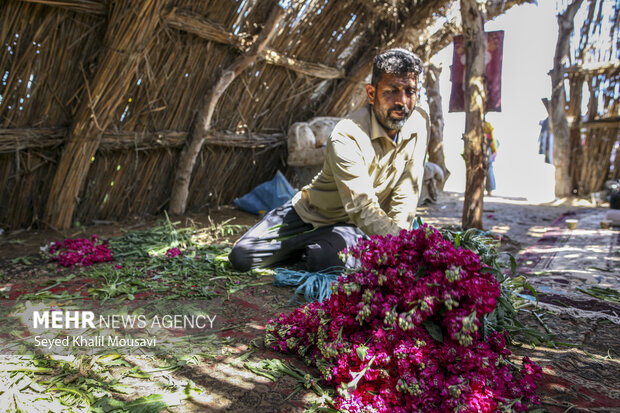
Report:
265,225,541,413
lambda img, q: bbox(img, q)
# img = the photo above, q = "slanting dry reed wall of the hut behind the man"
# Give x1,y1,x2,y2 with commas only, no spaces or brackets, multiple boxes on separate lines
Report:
0,0,615,229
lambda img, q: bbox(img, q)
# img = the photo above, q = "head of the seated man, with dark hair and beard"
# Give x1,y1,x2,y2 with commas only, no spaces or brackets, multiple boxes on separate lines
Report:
366,49,422,137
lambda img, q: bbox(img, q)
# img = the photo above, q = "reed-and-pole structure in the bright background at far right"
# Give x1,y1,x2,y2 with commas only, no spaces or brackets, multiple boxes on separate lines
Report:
549,0,620,196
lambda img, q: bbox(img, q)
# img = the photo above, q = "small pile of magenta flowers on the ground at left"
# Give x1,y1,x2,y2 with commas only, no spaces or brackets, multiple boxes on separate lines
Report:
48,235,112,267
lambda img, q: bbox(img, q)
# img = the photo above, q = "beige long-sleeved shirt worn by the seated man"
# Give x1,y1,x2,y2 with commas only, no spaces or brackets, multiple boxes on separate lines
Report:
293,105,430,235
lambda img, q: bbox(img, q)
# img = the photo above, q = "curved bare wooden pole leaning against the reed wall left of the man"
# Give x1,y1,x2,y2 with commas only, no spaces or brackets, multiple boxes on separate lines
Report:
168,4,284,214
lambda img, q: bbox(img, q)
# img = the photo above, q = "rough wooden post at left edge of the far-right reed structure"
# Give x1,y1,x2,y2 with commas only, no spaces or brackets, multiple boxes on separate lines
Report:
549,0,583,196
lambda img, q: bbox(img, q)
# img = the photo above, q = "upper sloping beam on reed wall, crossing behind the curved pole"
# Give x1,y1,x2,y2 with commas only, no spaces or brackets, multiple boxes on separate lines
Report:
166,9,344,79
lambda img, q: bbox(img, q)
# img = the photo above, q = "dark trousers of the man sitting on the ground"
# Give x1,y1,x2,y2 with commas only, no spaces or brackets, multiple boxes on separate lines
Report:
228,201,366,271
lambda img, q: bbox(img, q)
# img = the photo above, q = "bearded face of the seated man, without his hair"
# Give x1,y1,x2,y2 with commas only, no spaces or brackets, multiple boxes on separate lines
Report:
366,73,418,134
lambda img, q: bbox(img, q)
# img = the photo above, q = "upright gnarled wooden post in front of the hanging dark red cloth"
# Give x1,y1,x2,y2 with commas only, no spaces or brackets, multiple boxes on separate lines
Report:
461,0,487,228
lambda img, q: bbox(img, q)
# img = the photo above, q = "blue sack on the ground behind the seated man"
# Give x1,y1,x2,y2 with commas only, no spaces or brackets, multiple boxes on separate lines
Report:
233,171,295,215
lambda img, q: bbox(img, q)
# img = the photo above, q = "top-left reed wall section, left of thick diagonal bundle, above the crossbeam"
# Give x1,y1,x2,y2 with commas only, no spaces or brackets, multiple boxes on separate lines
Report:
0,1,103,128
